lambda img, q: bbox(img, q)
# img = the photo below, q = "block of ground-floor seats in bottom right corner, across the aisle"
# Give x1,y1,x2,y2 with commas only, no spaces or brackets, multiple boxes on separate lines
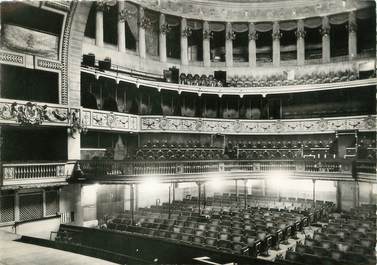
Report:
287,205,376,265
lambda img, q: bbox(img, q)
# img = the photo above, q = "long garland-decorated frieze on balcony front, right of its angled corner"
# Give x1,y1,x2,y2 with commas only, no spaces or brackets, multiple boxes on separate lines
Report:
140,116,376,134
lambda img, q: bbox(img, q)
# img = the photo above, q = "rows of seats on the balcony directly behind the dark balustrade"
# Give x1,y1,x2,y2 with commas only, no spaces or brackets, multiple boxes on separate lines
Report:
135,141,340,160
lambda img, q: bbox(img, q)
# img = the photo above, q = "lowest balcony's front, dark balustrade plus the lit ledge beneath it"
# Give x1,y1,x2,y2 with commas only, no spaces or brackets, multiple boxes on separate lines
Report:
78,160,354,183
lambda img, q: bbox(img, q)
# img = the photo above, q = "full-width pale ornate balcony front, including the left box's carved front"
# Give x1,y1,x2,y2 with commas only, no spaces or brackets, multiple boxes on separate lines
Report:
0,98,377,135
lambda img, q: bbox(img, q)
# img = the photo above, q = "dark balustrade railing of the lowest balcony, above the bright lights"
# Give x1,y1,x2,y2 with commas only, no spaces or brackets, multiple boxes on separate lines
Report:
78,160,352,178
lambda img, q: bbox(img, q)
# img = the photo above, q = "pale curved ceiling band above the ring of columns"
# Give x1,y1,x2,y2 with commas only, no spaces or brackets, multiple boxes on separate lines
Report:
131,0,373,22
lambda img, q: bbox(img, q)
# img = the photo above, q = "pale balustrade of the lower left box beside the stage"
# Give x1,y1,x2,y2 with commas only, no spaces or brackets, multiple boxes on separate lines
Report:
1,161,75,185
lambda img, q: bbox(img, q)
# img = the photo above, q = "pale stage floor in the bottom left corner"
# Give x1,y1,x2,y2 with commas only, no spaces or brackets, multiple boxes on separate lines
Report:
0,232,116,265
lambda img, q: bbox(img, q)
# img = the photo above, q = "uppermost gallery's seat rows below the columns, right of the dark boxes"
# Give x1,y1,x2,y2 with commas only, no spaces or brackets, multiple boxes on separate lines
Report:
228,70,358,87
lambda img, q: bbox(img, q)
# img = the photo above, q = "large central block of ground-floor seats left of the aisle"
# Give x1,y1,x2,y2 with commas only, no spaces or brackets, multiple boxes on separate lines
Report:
103,196,331,256
